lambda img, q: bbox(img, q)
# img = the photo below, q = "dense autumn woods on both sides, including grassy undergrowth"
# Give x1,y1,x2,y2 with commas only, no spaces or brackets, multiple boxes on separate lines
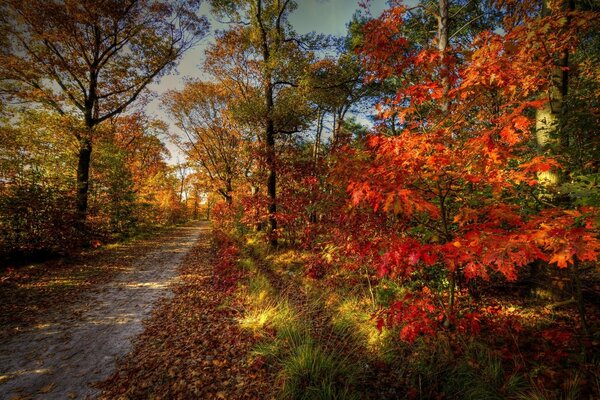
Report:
0,0,600,399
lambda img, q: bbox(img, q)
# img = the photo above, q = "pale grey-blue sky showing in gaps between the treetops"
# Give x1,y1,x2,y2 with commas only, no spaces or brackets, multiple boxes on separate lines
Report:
146,0,386,163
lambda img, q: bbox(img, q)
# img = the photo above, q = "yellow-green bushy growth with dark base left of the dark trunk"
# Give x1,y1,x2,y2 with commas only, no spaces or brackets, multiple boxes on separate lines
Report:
0,109,77,259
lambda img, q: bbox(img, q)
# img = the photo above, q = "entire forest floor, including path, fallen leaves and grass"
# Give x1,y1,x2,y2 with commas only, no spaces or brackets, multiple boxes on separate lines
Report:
0,224,600,399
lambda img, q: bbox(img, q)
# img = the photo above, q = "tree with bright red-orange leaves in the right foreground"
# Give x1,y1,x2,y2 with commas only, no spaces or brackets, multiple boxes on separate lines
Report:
334,0,600,340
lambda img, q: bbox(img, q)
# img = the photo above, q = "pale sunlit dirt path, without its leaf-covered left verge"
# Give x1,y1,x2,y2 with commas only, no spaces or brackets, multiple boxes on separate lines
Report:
0,225,208,399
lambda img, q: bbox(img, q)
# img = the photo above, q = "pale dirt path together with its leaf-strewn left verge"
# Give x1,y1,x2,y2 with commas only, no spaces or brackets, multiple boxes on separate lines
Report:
0,224,208,399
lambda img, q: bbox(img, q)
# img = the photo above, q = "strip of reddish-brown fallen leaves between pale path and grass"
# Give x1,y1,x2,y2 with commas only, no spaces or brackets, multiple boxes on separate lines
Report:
99,230,274,399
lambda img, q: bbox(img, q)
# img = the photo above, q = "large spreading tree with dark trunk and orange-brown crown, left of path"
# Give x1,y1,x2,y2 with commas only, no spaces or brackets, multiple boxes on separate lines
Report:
0,0,207,223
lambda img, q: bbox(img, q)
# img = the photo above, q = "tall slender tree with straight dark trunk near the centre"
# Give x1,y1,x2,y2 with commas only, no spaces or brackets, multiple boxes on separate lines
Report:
206,0,306,246
